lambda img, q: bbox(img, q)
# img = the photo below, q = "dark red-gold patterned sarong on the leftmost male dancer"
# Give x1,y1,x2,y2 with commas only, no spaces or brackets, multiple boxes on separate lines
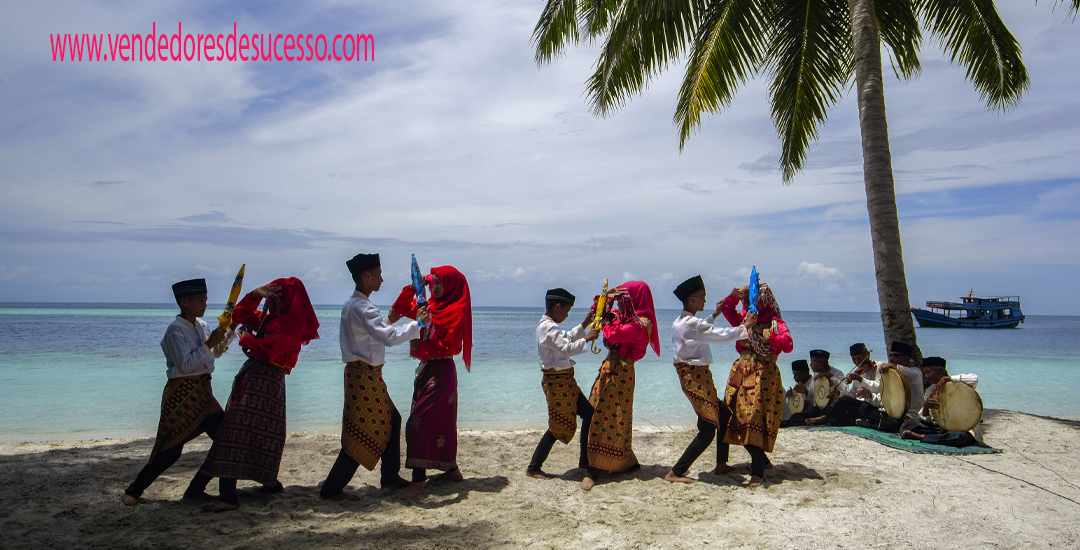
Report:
150,374,221,462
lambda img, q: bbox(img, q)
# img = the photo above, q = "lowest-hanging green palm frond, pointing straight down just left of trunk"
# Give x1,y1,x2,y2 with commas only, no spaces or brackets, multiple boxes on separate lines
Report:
767,0,855,183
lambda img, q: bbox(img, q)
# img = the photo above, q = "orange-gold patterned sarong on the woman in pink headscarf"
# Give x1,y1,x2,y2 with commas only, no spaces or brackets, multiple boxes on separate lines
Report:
589,353,637,472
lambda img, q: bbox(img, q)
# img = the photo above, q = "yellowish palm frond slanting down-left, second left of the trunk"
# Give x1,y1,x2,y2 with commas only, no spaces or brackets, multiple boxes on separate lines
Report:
675,0,770,150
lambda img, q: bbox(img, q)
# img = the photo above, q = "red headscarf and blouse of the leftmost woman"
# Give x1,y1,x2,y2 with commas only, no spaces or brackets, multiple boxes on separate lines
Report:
232,277,319,374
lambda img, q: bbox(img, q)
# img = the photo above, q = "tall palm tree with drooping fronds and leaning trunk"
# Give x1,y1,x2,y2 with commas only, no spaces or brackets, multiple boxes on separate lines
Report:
532,0,1028,352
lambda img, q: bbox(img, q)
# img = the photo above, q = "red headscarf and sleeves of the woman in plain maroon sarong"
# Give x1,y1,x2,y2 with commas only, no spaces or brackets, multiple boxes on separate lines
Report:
391,266,472,372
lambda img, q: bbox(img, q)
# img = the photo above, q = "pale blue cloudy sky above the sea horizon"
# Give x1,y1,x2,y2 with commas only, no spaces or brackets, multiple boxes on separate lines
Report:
0,0,1080,314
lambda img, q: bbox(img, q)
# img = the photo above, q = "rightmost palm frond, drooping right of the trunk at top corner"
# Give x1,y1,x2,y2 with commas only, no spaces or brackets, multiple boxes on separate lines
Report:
920,0,1030,110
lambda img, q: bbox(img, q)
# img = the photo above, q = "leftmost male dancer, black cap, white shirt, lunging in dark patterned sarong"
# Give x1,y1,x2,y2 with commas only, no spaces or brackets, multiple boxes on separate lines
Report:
121,279,232,506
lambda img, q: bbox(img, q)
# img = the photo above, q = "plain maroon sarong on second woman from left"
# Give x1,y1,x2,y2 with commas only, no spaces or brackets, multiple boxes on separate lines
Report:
405,358,458,471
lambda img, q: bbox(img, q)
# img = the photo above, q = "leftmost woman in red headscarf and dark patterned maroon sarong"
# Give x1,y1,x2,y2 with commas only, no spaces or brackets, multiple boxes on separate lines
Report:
192,277,319,512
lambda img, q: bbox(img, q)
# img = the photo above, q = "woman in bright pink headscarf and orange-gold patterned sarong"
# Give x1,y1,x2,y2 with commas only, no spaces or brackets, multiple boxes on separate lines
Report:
581,281,660,491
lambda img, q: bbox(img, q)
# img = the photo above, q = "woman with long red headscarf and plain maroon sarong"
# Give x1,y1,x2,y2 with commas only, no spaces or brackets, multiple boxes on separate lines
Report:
388,266,472,500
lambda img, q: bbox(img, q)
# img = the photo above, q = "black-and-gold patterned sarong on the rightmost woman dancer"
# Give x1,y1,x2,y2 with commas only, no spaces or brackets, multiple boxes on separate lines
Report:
724,349,784,453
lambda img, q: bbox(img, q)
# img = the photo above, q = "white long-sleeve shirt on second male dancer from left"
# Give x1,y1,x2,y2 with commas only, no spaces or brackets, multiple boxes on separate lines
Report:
338,291,420,366
